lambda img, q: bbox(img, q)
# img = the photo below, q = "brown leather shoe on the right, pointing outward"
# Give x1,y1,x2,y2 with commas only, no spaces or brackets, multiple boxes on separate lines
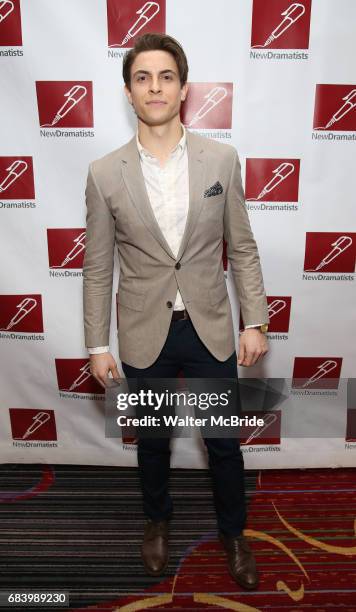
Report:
219,531,258,589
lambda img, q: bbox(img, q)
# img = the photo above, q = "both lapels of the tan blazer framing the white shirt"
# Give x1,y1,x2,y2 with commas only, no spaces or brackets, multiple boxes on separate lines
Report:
121,130,206,260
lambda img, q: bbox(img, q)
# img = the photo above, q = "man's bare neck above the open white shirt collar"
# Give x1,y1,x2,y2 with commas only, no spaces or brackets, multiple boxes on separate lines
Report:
138,115,183,160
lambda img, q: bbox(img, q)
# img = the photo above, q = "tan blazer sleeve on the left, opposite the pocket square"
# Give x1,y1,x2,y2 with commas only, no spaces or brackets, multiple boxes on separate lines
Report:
83,164,115,347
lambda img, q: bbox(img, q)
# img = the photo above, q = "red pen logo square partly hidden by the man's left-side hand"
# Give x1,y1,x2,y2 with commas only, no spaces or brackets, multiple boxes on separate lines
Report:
55,359,105,395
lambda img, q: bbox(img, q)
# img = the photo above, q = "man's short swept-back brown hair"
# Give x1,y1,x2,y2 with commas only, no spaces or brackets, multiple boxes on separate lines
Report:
122,32,188,90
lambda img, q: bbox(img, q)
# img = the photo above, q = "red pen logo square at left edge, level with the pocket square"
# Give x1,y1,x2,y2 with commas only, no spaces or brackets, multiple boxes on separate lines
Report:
0,156,35,200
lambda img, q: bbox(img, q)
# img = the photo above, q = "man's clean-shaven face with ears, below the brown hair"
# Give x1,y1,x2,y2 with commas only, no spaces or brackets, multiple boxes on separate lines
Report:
125,50,188,126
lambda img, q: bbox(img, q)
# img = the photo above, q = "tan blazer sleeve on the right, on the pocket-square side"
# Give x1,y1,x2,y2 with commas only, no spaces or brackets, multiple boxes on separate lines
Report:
224,149,269,326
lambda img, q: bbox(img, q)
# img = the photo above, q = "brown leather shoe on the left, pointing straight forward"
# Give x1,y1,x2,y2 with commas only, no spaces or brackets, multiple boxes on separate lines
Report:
141,520,168,576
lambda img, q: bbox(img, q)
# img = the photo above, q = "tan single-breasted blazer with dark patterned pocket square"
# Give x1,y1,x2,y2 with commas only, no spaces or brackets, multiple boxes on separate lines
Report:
83,130,268,368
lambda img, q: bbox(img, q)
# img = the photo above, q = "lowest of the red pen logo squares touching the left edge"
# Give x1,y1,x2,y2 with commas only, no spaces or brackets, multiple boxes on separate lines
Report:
0,294,43,333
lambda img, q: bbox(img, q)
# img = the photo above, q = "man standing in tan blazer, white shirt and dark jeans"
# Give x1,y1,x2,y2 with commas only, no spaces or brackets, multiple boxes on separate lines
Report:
84,34,268,589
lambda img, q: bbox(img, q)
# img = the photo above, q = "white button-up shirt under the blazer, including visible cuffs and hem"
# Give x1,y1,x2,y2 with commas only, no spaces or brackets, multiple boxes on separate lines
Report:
88,123,262,354
